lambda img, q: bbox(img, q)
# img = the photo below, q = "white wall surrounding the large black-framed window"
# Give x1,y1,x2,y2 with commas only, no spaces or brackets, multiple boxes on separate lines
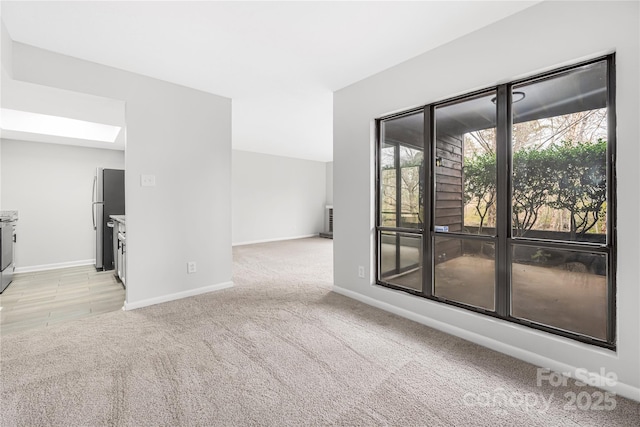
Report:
334,2,640,400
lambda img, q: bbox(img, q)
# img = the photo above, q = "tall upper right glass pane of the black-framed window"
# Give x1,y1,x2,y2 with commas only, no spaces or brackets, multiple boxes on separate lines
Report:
512,61,607,243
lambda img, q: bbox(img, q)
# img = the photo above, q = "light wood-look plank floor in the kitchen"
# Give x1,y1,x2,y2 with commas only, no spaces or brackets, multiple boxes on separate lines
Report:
0,265,125,335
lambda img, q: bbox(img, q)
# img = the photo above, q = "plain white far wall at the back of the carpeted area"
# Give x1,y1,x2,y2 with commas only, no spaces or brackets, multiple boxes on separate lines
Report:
232,150,326,244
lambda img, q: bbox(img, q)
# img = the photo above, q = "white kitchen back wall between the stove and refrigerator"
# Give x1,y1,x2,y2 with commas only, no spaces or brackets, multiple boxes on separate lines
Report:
0,139,124,271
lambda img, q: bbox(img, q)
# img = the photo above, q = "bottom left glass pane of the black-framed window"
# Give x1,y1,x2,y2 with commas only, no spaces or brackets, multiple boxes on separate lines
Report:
380,231,422,291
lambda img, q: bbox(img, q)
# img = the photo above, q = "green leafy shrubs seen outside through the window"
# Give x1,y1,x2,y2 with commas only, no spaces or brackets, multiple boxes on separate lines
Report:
464,139,607,240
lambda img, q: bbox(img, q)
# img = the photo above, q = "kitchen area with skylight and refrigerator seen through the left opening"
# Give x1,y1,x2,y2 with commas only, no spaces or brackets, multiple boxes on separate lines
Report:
0,78,126,335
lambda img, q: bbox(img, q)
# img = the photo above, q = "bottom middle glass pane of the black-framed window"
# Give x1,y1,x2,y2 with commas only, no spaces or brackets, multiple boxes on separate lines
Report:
433,237,495,310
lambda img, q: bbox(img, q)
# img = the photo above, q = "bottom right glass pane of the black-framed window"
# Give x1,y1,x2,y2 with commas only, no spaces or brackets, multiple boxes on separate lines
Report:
511,246,607,340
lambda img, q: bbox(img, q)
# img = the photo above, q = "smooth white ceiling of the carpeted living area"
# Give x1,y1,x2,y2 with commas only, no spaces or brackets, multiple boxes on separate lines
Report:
1,1,539,161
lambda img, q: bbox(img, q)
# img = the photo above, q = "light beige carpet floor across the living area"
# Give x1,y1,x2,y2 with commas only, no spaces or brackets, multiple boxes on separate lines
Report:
0,238,640,426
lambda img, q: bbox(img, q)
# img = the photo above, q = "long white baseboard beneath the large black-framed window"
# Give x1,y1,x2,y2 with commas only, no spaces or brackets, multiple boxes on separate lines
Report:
332,286,640,402
